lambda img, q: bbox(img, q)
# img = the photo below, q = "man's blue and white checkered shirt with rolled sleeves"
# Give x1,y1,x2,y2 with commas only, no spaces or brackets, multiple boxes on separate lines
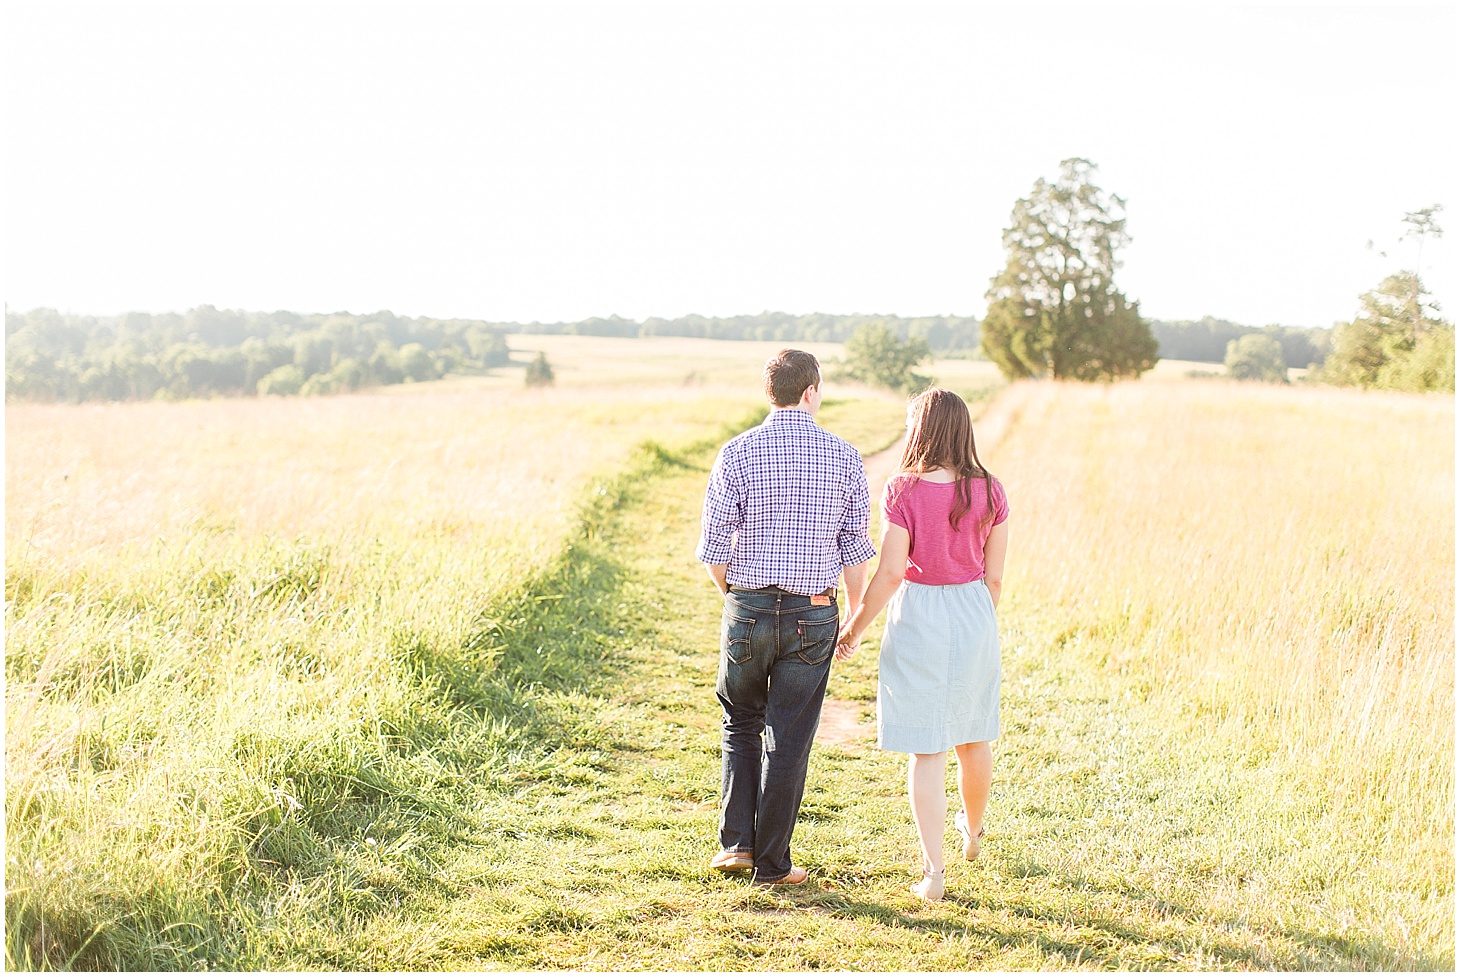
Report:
695,409,876,594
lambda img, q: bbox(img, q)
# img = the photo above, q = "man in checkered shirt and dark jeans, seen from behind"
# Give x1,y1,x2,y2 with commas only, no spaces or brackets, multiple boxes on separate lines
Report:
696,349,876,885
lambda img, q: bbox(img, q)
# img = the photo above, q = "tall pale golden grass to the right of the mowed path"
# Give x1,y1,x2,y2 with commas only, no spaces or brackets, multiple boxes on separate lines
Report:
987,380,1454,891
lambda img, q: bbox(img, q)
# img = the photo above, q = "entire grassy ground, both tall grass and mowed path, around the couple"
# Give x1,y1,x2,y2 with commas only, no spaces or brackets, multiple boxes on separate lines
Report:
6,344,1454,970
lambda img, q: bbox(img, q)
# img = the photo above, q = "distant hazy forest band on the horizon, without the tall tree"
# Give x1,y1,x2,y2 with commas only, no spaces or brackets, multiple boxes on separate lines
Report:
6,305,1329,402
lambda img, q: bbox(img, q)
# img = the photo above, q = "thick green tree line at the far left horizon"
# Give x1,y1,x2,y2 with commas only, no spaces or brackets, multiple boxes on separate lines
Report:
4,305,508,402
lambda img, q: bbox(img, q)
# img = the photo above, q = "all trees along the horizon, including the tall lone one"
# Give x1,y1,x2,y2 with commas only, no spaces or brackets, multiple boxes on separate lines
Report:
6,175,1454,400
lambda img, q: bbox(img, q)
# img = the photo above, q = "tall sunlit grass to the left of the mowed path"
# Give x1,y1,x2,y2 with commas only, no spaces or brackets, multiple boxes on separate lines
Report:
6,379,753,968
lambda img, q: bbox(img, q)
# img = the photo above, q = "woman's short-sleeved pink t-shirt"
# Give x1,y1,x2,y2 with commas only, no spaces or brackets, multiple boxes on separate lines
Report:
882,473,1009,587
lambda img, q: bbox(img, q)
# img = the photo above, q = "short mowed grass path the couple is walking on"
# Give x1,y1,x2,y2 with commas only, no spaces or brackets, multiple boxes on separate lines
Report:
414,385,1453,970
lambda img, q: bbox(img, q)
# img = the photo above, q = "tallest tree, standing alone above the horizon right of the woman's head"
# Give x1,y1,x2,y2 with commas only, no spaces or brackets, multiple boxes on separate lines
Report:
981,159,1156,380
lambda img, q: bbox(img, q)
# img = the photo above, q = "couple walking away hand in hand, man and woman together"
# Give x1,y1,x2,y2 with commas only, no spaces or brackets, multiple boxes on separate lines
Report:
696,349,1009,900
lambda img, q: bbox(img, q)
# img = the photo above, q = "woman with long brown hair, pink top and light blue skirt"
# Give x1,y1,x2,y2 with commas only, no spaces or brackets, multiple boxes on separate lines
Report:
837,390,1009,901
